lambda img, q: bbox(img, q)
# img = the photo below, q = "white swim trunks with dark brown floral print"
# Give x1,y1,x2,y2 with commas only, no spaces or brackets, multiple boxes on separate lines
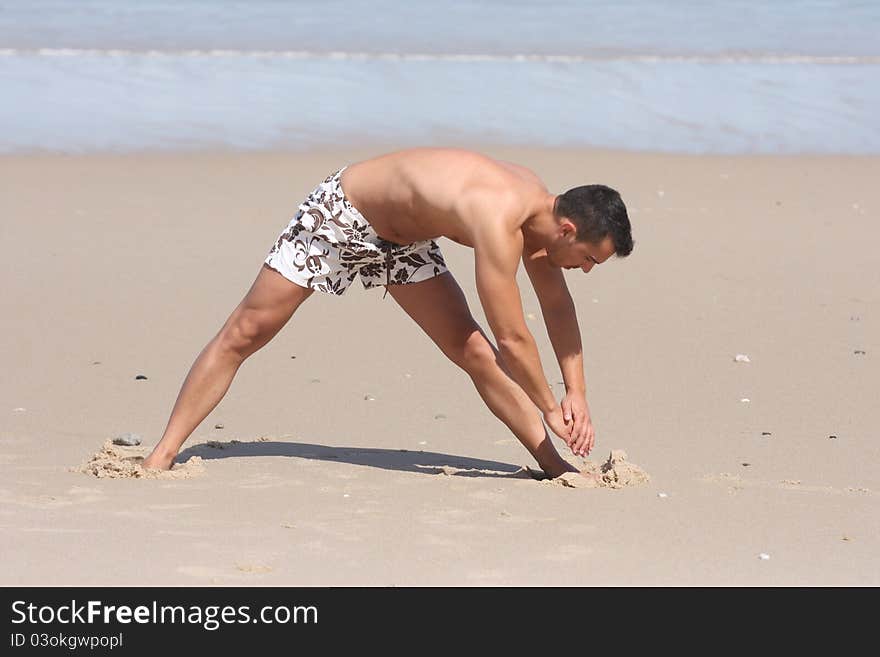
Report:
265,167,447,294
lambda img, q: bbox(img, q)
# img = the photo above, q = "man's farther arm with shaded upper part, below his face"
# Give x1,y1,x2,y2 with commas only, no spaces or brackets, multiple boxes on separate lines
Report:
523,249,595,456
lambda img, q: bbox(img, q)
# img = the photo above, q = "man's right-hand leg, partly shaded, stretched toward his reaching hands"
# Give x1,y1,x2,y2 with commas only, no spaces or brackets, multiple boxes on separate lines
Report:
388,272,577,477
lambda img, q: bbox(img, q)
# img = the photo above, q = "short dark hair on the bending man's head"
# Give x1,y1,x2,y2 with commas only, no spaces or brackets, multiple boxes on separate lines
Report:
553,185,633,258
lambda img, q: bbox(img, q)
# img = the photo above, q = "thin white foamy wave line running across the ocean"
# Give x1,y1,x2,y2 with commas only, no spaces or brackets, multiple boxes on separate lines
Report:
0,48,880,66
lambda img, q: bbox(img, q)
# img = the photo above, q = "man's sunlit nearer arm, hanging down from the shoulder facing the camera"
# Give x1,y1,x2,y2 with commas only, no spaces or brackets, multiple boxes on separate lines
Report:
473,202,571,444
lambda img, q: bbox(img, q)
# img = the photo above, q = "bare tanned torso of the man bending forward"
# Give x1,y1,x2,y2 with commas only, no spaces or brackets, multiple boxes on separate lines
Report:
342,148,549,246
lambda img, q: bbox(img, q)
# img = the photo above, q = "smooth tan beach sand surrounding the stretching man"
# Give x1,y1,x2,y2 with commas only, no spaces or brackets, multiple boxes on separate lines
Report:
0,148,880,586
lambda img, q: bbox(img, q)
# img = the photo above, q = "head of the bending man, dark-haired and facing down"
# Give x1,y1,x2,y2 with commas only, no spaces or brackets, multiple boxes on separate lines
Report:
547,185,633,272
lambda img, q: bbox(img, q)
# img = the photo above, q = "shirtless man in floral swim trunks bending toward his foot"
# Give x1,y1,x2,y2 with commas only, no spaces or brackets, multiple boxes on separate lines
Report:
144,148,633,477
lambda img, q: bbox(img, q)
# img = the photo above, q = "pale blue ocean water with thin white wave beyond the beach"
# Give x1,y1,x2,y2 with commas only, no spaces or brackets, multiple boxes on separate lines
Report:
0,0,880,154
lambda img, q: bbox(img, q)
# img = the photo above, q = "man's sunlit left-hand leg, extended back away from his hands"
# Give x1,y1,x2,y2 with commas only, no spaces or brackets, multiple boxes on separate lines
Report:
144,265,312,470
